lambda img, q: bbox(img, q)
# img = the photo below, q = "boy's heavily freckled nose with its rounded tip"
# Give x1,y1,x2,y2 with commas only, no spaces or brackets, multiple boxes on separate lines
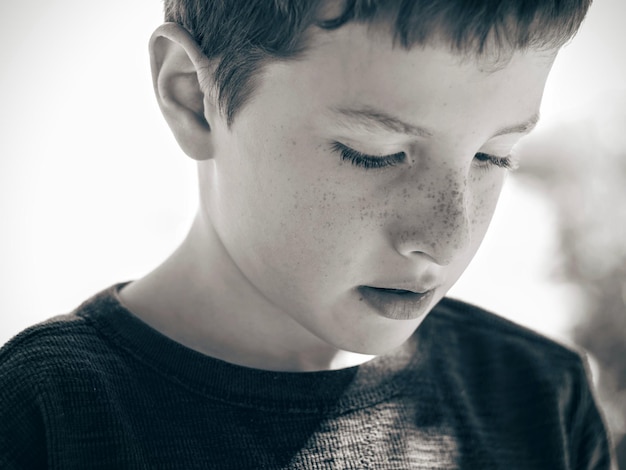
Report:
390,170,471,266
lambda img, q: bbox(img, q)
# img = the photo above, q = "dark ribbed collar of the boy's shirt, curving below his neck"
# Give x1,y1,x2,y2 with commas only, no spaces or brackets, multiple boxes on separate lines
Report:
75,283,428,413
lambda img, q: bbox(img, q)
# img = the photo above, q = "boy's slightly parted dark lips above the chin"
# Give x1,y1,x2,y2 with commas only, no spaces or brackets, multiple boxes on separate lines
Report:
357,286,435,320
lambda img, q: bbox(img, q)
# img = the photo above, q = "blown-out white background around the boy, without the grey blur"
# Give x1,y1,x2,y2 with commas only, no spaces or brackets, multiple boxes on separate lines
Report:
0,0,626,344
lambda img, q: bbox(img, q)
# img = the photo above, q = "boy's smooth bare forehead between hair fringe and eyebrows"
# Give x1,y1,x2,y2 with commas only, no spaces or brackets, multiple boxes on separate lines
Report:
247,23,553,140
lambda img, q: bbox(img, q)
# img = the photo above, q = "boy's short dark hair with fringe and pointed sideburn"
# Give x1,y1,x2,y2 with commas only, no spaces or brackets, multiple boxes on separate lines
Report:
165,0,592,125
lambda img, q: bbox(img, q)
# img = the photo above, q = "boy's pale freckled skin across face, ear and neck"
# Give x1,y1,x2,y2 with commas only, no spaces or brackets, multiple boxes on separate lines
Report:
120,20,556,371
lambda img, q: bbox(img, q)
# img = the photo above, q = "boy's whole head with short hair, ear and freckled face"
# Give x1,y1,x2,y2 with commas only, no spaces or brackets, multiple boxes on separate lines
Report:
151,0,589,354
